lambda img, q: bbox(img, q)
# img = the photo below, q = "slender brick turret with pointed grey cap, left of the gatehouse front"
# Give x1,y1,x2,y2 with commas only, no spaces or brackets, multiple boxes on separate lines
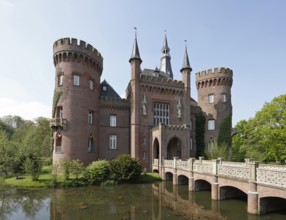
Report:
129,33,142,158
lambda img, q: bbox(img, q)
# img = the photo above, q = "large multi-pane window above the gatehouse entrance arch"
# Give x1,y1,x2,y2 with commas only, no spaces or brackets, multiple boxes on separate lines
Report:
154,103,169,125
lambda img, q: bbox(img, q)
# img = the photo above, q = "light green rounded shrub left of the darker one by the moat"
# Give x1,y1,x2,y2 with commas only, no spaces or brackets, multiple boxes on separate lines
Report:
83,160,110,185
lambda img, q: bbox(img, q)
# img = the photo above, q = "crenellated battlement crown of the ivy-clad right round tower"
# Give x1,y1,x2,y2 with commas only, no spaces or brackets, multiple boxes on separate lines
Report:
196,67,233,81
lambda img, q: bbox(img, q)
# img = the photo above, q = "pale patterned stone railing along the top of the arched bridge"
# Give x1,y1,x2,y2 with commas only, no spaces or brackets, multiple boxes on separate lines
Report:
154,157,286,188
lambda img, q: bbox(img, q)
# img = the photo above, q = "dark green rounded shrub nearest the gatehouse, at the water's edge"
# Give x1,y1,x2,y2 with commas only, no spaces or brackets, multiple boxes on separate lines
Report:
110,154,142,182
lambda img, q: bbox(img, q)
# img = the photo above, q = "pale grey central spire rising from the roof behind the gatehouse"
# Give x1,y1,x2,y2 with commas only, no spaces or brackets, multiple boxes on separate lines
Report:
160,35,173,79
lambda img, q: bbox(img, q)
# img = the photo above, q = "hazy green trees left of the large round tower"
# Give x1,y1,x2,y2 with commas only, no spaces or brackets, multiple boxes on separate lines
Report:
0,116,51,175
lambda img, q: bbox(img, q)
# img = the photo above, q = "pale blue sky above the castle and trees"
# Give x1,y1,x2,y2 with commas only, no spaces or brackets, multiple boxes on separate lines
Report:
0,0,286,125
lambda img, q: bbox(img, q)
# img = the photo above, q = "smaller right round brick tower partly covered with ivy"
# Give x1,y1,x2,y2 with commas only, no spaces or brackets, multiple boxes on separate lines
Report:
196,68,233,150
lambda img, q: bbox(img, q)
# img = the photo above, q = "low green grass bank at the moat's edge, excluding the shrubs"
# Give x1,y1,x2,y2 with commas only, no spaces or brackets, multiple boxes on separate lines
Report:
0,166,161,188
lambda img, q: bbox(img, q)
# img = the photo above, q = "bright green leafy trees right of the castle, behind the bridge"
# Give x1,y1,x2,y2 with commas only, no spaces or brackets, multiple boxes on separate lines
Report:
233,95,286,161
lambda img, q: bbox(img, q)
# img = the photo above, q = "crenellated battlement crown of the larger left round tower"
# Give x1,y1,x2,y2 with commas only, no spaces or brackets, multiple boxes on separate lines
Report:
53,38,103,66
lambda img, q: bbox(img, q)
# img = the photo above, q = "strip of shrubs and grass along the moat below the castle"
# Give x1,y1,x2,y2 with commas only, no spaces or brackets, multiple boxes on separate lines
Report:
0,155,161,187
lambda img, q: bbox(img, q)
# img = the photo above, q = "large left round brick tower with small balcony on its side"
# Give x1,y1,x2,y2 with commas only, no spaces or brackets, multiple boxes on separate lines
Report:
51,38,103,164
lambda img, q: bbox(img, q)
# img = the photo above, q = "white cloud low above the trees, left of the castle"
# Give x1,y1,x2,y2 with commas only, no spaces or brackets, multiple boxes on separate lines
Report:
0,98,52,120
